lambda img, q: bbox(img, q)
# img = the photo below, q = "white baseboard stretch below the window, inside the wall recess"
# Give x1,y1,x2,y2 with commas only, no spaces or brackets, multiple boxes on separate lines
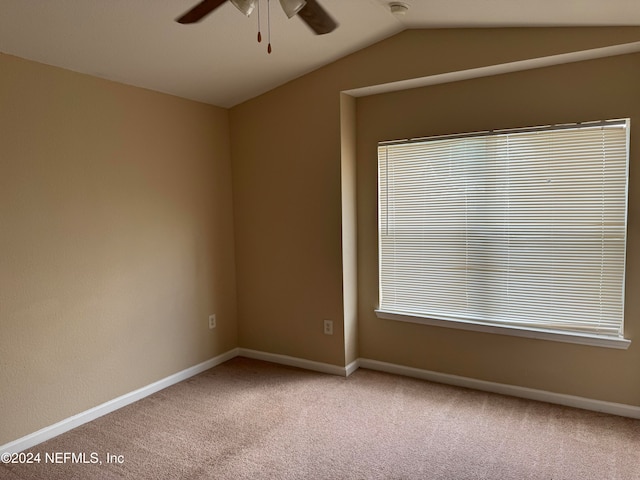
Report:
358,358,640,419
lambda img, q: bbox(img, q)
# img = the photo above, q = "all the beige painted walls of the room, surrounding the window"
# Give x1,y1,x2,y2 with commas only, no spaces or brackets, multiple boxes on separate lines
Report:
0,28,640,444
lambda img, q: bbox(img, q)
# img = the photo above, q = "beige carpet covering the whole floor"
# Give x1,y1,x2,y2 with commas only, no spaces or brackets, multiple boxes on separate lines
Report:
0,358,640,480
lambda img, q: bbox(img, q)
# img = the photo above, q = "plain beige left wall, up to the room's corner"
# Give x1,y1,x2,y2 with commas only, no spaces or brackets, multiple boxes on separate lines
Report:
0,51,237,445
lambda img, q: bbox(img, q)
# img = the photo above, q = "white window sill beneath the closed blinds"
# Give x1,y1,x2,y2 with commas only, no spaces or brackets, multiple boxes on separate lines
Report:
375,310,631,350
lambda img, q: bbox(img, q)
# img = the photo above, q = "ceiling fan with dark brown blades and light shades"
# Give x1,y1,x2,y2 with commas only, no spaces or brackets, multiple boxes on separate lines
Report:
176,0,338,35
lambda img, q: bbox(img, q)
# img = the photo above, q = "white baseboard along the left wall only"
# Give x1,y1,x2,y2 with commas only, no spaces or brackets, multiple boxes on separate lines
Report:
0,348,239,455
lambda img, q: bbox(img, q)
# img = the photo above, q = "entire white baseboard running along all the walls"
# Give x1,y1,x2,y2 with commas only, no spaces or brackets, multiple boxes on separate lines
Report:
0,348,640,455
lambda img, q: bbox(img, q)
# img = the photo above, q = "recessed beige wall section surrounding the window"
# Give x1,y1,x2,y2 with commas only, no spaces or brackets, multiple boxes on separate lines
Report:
357,54,640,405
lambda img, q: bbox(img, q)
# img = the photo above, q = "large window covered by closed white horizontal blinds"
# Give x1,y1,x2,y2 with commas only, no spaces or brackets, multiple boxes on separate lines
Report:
376,120,630,348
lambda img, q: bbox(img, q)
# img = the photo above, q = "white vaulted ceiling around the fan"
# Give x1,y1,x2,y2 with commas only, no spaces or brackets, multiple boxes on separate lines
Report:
0,0,640,107
